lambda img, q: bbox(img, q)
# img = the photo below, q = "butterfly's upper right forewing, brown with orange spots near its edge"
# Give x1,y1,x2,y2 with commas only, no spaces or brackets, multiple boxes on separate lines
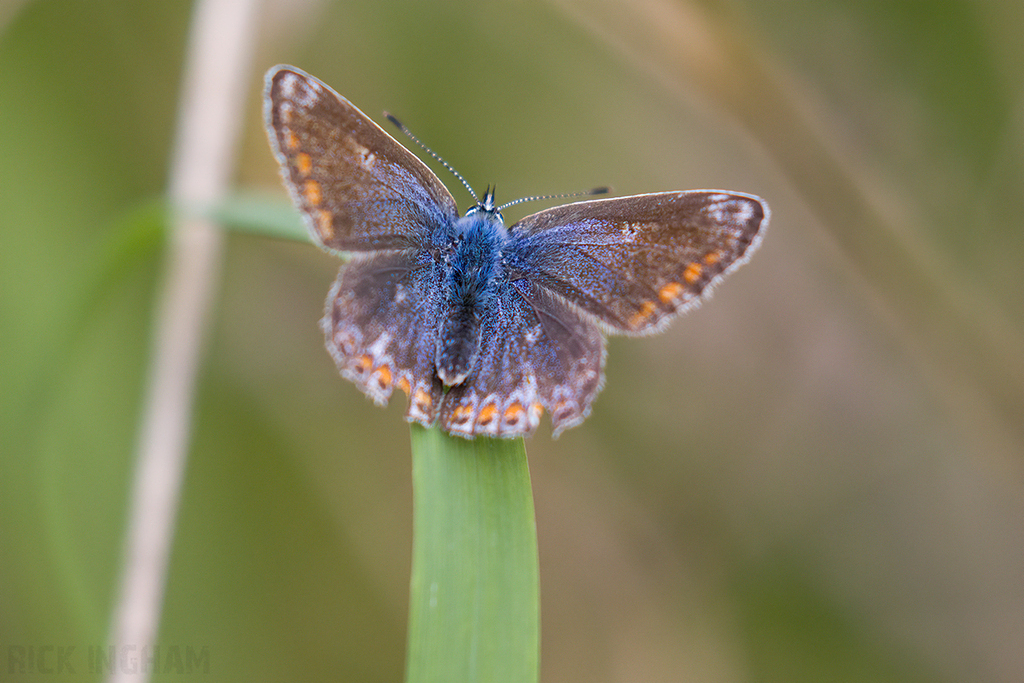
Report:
509,190,769,334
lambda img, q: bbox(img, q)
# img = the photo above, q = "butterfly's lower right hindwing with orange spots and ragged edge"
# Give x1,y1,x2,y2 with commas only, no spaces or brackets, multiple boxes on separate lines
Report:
439,280,604,437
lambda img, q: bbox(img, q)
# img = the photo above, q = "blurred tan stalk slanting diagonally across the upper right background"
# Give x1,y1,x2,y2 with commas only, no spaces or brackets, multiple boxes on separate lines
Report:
552,0,1024,458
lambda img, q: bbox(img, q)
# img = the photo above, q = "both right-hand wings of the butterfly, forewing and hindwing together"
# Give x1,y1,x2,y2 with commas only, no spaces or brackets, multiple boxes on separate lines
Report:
439,190,768,436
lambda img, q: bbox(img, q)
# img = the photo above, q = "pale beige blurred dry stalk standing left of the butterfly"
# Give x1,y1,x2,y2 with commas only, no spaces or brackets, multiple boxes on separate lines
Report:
110,0,258,681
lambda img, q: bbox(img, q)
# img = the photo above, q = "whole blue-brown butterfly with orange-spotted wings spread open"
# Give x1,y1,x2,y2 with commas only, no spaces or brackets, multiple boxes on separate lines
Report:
264,67,769,438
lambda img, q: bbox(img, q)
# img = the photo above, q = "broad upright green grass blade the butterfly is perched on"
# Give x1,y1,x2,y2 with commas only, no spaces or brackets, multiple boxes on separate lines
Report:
406,425,540,683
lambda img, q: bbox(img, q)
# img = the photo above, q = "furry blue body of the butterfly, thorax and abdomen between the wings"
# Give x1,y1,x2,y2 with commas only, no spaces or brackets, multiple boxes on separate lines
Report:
435,214,505,386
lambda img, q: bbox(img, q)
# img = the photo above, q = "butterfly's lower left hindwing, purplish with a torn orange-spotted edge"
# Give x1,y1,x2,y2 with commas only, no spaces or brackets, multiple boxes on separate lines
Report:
321,250,443,426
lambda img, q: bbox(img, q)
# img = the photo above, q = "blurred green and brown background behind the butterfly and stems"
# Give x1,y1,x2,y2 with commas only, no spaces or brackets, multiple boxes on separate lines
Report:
0,0,1024,683
